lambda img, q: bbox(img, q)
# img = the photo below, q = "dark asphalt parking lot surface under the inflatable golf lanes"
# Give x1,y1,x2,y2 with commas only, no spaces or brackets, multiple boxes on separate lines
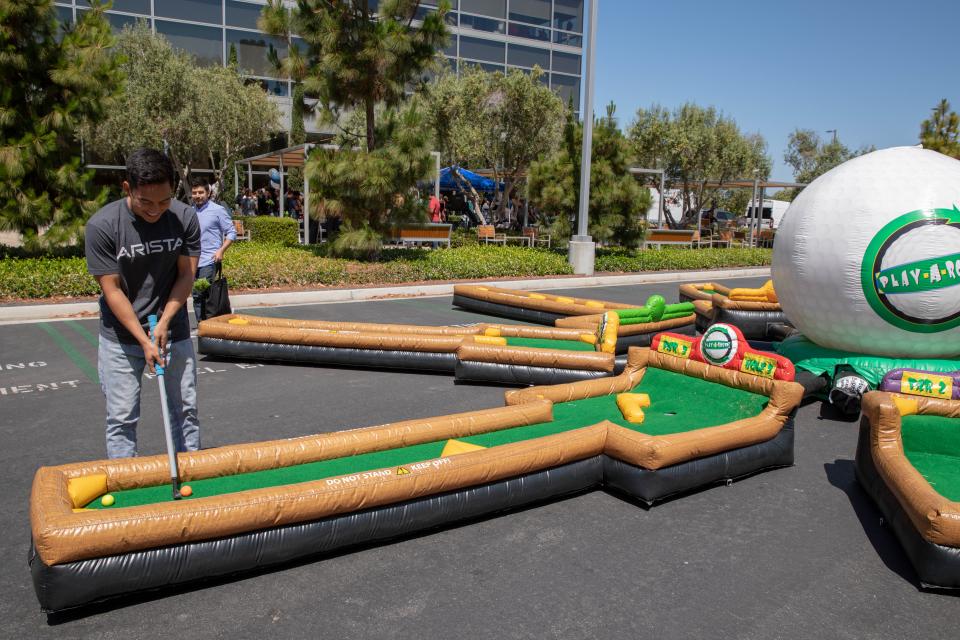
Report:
0,279,960,640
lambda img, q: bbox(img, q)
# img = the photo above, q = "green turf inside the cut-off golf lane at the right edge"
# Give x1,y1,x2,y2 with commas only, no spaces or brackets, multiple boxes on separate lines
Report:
901,416,960,502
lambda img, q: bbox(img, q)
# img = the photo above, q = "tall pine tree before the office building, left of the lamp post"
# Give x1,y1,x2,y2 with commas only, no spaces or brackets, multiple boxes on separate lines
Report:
258,0,450,242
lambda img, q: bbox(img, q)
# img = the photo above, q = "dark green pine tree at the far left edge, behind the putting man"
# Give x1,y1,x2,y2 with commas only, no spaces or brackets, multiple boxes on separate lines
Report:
0,0,122,248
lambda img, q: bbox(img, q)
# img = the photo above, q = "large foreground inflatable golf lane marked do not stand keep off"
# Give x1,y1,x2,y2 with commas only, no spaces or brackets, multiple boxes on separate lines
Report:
31,334,802,611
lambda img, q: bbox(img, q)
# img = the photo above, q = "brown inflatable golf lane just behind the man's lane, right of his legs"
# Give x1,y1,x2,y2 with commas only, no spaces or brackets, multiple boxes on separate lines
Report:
198,314,625,386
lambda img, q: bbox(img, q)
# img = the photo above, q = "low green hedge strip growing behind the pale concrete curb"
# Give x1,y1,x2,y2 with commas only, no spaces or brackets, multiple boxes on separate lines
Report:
0,242,771,300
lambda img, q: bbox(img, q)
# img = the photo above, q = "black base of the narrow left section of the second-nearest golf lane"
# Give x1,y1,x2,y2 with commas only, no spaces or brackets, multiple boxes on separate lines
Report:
197,338,457,373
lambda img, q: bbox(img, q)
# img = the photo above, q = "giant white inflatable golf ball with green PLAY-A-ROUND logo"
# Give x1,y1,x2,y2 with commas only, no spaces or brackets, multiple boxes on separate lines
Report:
773,147,960,358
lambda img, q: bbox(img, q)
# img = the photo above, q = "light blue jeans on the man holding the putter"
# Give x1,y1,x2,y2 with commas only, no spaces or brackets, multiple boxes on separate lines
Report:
97,336,200,458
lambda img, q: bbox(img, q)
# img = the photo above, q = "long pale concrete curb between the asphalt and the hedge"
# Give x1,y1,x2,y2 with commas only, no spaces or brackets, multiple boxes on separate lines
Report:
0,267,770,324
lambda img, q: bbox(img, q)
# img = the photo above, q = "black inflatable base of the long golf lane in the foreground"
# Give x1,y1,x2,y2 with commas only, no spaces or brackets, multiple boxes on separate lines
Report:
29,416,793,613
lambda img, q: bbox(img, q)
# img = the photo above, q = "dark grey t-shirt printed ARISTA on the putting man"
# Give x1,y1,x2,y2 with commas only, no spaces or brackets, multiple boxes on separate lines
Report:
86,198,200,344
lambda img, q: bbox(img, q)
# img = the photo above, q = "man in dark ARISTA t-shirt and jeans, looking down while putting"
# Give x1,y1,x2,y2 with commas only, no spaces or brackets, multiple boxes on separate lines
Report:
86,149,200,458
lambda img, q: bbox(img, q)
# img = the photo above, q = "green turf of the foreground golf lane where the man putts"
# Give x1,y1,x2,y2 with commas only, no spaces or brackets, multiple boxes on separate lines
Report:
87,367,767,509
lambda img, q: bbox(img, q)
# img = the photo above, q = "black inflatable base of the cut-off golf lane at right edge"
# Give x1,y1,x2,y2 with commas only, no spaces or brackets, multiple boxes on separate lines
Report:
855,418,960,589
